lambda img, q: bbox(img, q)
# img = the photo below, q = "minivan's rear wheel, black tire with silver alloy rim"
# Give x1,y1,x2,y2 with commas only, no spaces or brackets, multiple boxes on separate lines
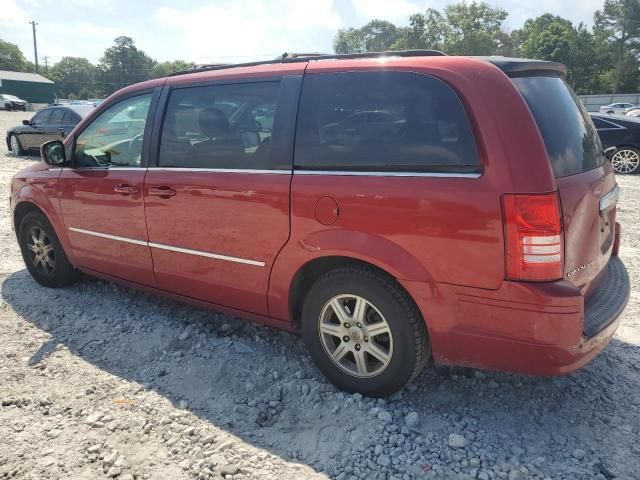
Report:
302,266,430,397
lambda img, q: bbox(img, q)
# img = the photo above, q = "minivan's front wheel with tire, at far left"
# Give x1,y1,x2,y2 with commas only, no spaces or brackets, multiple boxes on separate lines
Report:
18,212,76,288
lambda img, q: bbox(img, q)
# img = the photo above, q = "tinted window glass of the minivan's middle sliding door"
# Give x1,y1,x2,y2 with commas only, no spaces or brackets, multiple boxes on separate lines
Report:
159,82,279,170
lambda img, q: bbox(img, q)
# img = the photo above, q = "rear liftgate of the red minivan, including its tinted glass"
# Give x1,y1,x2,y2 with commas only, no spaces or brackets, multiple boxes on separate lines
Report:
512,75,617,296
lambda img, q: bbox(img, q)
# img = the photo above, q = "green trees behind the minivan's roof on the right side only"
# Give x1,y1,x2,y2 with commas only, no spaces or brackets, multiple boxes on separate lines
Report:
333,0,640,94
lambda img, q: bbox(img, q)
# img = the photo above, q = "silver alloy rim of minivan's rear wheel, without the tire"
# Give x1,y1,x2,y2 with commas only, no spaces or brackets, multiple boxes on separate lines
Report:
318,294,393,378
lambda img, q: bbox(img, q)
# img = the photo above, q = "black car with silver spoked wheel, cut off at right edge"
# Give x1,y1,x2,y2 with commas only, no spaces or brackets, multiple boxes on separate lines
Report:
591,114,640,173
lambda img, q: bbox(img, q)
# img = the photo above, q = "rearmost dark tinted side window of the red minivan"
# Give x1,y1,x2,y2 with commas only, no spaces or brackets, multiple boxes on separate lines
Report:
294,71,481,173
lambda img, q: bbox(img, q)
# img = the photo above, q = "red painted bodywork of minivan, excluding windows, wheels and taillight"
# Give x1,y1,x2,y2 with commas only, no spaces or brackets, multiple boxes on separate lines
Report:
11,57,628,374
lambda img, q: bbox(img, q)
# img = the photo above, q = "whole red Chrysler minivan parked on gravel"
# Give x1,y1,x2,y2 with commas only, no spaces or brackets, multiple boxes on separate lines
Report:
11,51,630,396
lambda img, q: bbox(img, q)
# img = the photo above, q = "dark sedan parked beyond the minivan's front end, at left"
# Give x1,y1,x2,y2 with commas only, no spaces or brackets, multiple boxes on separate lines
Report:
7,105,95,155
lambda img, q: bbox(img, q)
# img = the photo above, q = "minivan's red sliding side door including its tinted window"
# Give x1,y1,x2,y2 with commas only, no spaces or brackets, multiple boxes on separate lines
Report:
144,76,301,314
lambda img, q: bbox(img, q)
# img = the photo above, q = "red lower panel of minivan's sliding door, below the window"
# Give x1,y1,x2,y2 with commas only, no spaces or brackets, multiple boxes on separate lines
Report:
145,169,291,314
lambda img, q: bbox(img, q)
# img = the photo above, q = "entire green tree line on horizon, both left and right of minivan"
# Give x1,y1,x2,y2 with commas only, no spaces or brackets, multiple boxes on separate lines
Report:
0,0,640,98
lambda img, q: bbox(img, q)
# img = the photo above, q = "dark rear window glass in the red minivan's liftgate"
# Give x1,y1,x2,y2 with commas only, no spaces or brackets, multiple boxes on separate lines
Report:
512,76,605,178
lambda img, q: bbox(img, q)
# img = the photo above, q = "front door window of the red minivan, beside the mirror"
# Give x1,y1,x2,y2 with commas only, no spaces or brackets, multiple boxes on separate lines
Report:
74,94,151,168
